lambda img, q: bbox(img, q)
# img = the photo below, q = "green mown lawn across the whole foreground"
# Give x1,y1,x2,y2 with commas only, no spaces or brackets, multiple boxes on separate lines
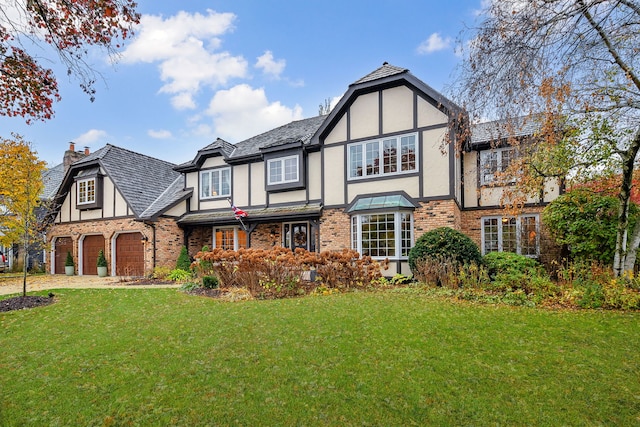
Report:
0,289,640,426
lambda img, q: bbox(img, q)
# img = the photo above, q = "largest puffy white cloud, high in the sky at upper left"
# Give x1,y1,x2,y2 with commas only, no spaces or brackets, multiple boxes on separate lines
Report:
122,9,248,109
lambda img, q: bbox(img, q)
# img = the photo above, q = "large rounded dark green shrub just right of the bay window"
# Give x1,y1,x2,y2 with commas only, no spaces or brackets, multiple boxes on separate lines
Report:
409,227,482,275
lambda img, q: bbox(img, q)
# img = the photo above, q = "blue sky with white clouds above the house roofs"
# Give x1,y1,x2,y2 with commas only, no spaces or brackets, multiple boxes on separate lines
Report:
0,0,486,166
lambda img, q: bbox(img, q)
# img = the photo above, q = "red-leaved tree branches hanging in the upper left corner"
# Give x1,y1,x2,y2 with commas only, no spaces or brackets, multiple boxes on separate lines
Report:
0,0,140,122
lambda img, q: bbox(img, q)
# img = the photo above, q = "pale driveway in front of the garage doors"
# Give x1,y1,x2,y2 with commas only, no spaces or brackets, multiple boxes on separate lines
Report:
0,273,180,295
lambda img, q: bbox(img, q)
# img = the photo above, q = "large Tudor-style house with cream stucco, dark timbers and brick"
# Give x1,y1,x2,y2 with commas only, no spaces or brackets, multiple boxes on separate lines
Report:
49,63,559,275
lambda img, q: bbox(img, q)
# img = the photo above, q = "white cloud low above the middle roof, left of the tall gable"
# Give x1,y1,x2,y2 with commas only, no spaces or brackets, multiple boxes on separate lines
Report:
207,84,302,142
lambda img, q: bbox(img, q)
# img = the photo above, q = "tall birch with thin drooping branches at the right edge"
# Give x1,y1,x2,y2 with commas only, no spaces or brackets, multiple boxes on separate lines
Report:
457,0,640,274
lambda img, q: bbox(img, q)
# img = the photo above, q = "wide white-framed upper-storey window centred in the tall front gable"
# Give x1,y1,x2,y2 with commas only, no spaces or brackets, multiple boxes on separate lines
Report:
347,134,418,179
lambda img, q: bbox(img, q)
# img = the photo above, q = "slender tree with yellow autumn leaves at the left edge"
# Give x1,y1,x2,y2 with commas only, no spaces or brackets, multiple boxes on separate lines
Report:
0,135,45,295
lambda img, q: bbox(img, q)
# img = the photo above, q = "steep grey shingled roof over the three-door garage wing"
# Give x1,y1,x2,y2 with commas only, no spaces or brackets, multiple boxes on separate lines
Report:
58,144,184,218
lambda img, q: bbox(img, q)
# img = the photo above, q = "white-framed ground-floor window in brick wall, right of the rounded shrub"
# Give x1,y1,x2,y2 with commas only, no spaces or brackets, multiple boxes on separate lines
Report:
481,214,540,257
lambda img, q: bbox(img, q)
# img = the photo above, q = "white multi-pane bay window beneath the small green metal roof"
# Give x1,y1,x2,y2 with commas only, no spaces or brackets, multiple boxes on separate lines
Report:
351,212,413,259
